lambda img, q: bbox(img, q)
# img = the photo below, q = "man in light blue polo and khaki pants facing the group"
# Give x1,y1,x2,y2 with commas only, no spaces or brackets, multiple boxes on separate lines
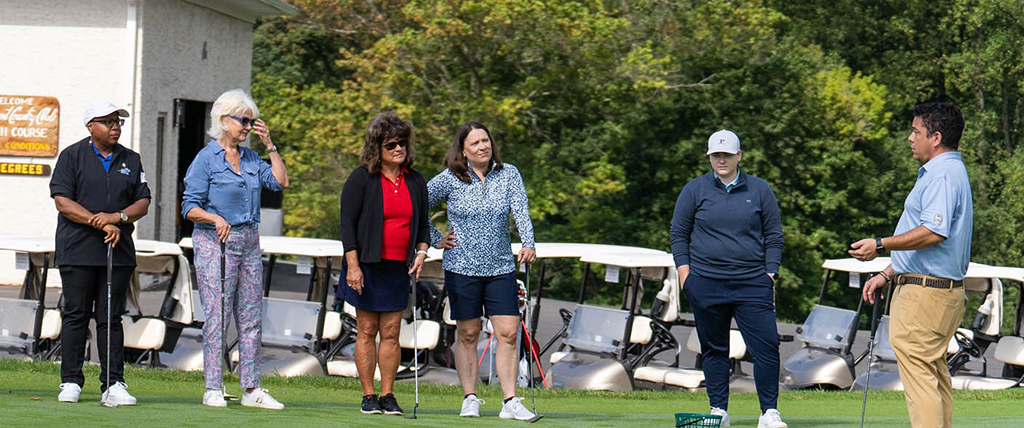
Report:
850,102,974,428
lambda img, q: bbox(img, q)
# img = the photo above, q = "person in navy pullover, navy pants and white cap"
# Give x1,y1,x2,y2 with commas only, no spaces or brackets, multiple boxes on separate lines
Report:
670,129,786,428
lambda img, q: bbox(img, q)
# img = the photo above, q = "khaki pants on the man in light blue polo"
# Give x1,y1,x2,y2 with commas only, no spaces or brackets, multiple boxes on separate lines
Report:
889,285,964,428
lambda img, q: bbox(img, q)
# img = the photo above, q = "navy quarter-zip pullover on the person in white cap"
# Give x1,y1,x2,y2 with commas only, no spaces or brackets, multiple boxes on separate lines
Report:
670,170,782,280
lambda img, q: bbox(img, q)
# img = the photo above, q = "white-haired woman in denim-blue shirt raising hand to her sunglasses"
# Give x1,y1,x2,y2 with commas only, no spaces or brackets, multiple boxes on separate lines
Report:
181,89,288,410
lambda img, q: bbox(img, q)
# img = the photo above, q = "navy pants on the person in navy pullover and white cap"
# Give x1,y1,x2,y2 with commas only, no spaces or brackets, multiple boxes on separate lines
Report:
683,273,779,413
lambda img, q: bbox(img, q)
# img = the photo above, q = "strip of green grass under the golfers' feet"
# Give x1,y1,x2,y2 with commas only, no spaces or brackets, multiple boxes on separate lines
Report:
6,359,1024,428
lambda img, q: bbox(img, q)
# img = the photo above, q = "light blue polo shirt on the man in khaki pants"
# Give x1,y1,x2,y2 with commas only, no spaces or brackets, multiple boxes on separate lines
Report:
892,152,974,280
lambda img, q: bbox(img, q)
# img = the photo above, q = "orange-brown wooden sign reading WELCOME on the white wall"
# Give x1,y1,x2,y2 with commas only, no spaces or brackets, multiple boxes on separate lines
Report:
0,95,60,157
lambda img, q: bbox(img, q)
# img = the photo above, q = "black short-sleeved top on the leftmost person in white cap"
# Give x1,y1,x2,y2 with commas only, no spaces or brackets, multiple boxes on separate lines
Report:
50,137,151,266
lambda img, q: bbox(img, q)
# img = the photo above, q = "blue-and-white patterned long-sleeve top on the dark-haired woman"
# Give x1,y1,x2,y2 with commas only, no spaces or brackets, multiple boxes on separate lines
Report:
427,164,534,276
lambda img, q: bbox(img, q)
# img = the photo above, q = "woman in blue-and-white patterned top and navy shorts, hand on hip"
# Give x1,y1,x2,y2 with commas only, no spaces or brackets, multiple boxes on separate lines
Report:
427,122,537,421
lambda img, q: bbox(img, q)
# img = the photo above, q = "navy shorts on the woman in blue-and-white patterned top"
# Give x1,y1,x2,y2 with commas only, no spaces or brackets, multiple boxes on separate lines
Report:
444,270,519,320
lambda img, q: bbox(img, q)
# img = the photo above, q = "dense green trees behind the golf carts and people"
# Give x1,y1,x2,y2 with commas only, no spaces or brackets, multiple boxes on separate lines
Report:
253,0,1024,320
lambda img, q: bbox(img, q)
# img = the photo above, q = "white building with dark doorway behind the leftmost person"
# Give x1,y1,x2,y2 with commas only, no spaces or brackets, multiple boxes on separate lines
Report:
0,0,297,284
